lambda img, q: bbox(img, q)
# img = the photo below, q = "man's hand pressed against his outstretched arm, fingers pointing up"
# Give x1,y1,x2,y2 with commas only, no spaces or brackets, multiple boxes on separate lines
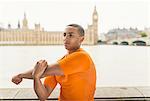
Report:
32,60,48,78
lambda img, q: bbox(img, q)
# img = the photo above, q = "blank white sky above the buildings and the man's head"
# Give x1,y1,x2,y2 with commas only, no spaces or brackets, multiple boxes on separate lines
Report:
0,0,150,33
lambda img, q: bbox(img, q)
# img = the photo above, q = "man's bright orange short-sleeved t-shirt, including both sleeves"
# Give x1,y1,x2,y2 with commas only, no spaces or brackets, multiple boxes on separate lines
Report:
44,48,96,101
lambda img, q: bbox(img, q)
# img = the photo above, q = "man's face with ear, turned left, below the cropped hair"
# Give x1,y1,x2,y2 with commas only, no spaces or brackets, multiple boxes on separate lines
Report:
64,26,84,51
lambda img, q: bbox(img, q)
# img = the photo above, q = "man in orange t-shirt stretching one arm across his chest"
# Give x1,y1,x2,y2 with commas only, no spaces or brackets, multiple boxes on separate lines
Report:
12,24,96,101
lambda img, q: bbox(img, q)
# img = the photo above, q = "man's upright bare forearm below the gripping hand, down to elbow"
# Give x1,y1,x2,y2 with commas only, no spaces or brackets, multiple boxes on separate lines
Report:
34,77,49,101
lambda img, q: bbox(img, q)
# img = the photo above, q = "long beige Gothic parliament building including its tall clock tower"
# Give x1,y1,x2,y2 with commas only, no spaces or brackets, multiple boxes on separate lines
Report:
0,7,98,45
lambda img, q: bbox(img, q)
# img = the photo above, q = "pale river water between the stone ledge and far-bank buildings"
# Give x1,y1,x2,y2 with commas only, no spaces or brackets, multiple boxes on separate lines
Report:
0,45,150,88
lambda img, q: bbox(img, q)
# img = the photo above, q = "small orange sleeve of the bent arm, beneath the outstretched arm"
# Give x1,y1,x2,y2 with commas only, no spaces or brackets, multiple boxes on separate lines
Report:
44,76,57,89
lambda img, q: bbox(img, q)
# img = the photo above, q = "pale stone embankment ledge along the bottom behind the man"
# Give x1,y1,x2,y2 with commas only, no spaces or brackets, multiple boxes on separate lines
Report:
0,86,150,101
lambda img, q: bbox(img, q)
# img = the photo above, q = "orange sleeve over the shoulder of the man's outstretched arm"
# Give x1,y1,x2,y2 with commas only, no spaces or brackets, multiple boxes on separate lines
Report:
58,52,90,75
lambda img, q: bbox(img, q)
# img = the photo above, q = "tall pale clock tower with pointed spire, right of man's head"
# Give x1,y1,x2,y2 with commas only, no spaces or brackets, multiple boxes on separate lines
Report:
92,6,98,44
